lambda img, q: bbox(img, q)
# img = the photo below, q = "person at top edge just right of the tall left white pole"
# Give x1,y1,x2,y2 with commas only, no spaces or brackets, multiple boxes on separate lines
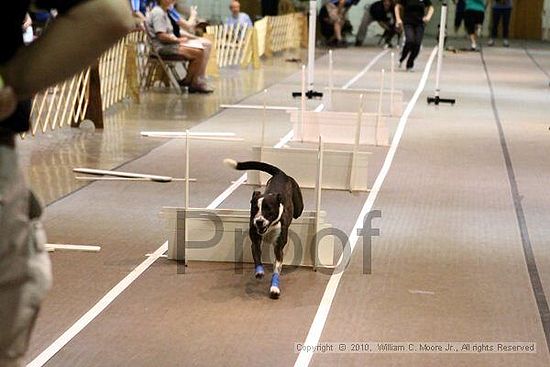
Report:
319,0,359,47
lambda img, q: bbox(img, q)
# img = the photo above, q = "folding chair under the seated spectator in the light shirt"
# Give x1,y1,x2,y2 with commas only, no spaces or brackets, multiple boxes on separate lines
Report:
144,22,188,94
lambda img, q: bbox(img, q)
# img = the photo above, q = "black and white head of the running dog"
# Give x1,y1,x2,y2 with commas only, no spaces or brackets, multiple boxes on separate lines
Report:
251,191,284,235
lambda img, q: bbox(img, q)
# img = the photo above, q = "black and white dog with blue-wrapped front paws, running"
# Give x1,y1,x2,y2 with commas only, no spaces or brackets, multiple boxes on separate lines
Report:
224,159,304,298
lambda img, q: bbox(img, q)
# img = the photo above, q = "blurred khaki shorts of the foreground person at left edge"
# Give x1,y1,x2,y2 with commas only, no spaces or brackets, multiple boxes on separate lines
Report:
0,145,52,367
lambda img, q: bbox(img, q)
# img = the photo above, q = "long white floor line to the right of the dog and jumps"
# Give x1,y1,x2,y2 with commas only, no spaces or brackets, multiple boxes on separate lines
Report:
294,47,437,367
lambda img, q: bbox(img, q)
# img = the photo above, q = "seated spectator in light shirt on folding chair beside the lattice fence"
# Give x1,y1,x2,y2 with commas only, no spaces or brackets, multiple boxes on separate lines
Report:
147,0,213,93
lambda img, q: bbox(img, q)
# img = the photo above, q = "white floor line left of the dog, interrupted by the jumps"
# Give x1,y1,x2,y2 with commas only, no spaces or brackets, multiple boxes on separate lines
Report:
27,54,392,367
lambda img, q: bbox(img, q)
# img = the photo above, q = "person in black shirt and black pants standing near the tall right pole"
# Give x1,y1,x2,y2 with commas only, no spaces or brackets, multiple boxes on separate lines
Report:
395,0,434,71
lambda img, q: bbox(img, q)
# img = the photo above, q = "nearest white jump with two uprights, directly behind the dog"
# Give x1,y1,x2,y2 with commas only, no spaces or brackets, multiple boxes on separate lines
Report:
161,138,335,268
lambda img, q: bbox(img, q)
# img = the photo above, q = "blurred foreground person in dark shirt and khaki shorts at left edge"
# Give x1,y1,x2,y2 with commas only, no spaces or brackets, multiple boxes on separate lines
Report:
0,0,135,367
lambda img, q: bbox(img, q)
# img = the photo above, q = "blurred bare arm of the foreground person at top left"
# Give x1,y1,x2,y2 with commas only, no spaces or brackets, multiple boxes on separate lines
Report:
0,0,134,100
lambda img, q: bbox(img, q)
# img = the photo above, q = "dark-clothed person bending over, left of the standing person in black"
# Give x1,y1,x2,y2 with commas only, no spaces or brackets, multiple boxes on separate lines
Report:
355,0,397,47
